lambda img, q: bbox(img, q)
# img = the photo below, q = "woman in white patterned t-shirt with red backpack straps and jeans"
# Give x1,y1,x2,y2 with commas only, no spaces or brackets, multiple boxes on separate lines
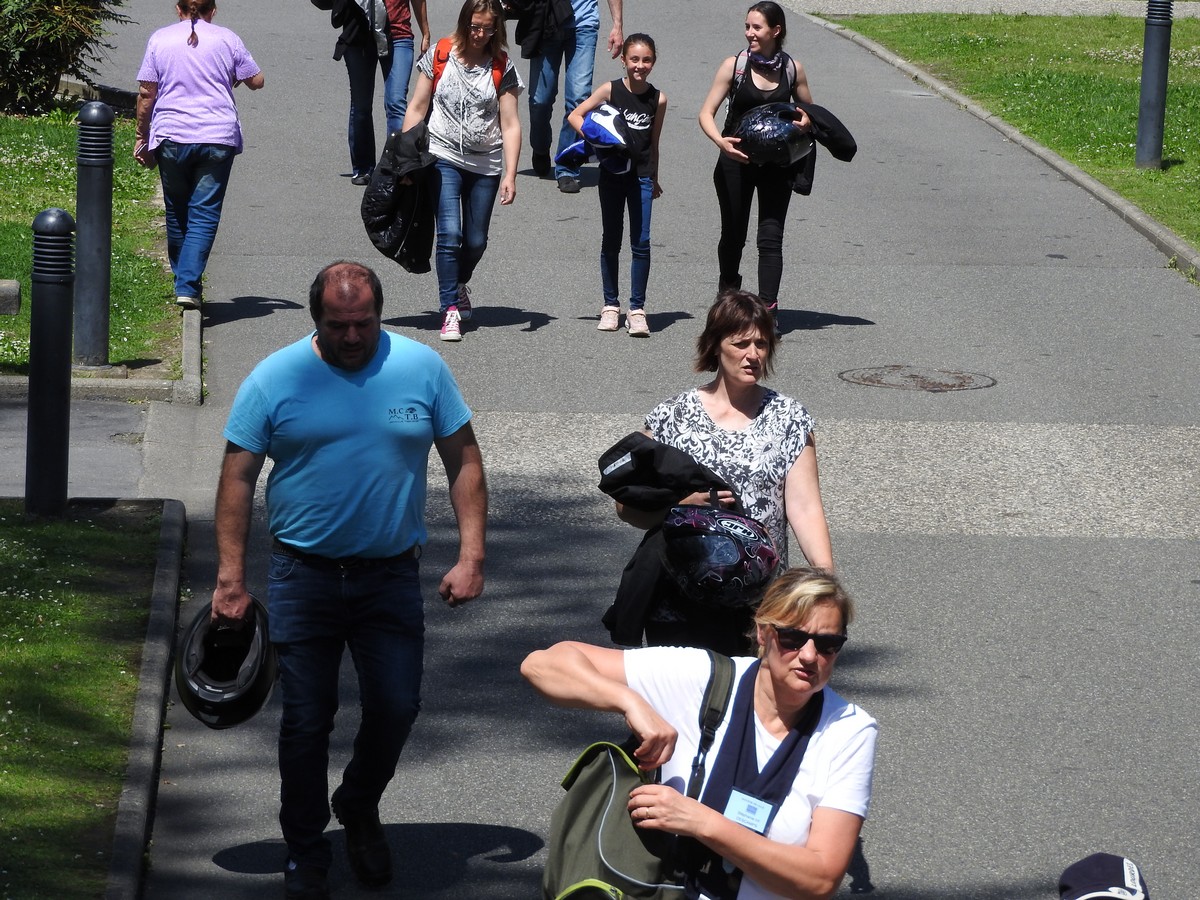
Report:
403,0,524,341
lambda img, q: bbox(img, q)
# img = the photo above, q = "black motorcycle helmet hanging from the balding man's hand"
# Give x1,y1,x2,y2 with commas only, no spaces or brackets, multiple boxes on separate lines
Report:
175,594,278,728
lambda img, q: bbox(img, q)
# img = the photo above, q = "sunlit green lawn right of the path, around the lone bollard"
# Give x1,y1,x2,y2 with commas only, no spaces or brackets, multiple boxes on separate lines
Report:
828,13,1200,256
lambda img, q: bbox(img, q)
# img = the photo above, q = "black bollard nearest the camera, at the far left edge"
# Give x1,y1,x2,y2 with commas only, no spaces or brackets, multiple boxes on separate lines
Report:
25,209,74,516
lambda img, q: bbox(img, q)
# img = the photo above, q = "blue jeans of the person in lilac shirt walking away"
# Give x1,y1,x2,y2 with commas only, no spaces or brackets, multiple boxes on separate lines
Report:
156,140,234,298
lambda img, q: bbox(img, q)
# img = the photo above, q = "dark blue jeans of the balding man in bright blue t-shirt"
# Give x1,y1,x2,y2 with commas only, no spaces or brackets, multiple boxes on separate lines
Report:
268,553,425,869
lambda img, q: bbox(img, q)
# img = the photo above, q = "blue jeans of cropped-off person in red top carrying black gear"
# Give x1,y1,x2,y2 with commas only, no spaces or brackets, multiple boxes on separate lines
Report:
342,37,413,175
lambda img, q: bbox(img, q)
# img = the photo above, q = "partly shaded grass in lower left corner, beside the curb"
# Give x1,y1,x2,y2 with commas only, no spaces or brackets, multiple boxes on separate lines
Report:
0,500,161,900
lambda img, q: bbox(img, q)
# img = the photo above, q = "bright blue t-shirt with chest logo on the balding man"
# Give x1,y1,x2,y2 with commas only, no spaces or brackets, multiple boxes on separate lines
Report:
224,331,470,558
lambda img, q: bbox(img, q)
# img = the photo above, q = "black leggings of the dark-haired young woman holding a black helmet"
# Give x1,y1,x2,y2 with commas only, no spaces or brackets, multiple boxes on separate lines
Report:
713,155,792,304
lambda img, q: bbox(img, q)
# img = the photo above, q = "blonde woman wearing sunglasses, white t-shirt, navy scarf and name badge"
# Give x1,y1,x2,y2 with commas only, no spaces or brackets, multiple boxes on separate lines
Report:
521,569,878,900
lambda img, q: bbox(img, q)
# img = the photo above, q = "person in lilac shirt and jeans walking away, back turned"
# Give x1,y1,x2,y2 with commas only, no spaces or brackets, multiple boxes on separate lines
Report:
133,0,263,310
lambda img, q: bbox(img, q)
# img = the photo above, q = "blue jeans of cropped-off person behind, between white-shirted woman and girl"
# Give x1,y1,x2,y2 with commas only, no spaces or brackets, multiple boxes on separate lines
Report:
529,25,600,178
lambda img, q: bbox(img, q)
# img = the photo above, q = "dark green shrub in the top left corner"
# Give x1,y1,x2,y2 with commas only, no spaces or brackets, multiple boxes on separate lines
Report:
0,0,128,114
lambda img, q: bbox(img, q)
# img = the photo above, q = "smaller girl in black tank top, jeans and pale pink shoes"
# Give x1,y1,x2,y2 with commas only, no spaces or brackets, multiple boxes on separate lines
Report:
568,34,667,337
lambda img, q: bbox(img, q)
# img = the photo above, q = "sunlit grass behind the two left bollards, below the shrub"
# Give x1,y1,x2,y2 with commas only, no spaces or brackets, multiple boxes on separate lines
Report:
0,110,181,378
